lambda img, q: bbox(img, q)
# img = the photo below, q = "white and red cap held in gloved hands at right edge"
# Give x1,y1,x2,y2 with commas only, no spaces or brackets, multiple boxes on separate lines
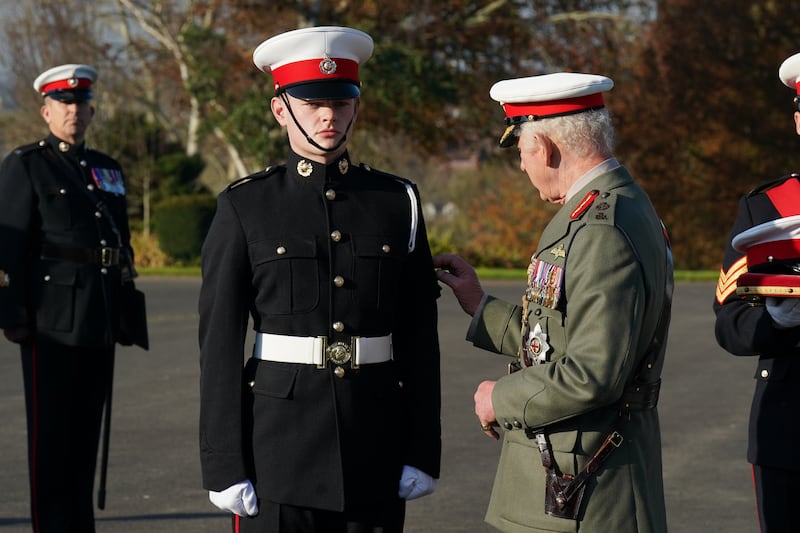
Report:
731,215,800,298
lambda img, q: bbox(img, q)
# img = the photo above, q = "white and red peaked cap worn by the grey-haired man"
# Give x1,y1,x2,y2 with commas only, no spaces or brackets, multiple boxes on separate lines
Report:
489,72,614,147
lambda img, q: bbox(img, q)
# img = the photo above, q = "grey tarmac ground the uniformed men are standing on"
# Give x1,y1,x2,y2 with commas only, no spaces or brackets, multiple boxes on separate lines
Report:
0,277,758,533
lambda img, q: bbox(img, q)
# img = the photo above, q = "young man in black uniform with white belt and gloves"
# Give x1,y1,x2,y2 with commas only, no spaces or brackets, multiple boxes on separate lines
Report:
199,27,441,533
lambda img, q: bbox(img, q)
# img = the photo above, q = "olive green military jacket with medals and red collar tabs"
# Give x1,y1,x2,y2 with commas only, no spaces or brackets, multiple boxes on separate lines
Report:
467,166,672,533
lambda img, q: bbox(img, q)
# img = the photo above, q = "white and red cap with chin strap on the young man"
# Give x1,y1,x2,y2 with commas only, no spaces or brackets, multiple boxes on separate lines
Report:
253,26,373,100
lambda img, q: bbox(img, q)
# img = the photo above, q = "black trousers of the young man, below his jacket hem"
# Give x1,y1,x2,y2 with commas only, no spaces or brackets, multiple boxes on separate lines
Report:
232,498,406,533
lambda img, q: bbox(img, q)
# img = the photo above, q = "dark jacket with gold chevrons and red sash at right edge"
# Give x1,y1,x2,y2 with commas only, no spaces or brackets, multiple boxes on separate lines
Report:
714,174,800,471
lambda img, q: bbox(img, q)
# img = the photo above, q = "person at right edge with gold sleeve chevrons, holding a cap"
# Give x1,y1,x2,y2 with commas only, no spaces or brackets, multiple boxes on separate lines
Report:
713,53,800,533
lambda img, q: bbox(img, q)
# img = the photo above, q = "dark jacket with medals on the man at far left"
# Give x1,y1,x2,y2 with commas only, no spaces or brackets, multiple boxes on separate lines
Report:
0,134,133,347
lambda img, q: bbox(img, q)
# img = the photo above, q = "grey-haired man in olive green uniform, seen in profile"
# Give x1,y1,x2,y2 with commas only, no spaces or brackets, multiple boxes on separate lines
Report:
434,73,672,533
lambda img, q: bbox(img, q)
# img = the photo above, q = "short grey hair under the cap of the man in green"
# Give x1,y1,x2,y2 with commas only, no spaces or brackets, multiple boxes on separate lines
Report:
520,108,614,157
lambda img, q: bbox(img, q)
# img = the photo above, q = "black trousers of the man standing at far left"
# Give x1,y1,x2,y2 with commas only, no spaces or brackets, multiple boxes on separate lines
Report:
21,340,114,533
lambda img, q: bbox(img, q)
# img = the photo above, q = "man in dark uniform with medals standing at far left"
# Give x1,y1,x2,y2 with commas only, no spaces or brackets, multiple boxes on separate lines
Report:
0,64,145,533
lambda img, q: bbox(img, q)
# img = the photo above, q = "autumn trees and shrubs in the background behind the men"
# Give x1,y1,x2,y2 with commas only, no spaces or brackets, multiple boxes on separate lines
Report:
0,0,800,269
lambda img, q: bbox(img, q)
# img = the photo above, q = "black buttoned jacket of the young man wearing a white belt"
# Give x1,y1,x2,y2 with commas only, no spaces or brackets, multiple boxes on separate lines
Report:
199,149,441,510
